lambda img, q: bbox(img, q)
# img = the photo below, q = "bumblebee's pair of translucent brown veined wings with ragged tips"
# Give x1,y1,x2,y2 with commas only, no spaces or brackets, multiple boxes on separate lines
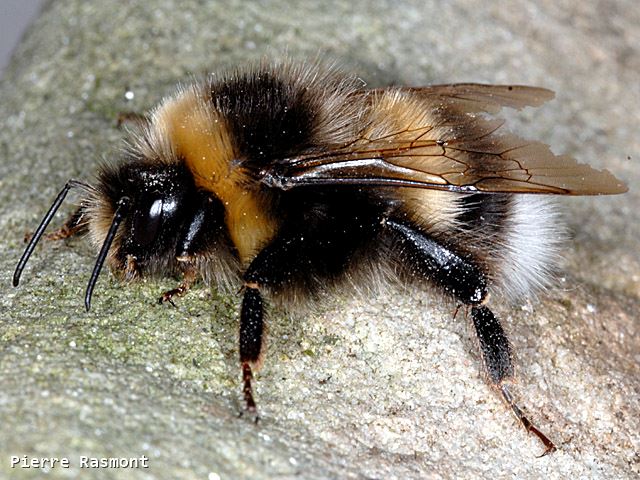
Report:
262,84,627,195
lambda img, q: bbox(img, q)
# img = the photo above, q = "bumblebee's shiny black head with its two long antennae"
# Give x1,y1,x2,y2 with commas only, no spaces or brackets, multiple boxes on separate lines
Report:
13,161,225,310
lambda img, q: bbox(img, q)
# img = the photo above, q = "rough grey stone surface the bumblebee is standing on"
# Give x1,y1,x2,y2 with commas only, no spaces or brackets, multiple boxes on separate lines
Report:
0,0,640,479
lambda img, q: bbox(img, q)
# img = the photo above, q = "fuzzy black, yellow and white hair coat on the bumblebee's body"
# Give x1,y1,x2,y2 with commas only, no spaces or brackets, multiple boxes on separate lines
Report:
79,63,596,312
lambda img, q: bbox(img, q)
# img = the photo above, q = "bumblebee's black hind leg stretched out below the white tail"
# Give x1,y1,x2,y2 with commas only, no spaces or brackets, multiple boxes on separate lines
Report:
384,219,556,455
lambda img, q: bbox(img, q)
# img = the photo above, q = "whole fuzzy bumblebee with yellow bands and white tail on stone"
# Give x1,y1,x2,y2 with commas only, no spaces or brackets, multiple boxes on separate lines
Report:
13,62,626,454
